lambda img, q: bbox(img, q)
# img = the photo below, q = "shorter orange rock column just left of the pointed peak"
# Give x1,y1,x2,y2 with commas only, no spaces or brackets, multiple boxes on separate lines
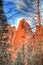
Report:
7,25,16,44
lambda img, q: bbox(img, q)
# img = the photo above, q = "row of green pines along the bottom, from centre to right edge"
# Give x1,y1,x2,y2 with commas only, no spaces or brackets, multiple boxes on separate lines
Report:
14,41,43,65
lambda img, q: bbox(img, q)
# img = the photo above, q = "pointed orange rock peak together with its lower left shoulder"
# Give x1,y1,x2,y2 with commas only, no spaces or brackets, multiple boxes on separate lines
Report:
8,19,33,59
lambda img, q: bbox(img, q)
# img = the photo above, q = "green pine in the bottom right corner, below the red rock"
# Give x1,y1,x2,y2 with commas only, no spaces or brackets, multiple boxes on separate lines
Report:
32,40,43,65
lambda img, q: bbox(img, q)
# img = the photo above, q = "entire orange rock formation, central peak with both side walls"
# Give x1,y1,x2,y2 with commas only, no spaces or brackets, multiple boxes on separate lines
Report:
8,19,43,59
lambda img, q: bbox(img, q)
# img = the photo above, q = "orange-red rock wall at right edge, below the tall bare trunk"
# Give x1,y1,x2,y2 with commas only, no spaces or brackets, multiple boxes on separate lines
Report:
34,25,43,53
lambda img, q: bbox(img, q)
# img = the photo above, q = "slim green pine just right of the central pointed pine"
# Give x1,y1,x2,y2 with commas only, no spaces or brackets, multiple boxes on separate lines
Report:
27,42,33,65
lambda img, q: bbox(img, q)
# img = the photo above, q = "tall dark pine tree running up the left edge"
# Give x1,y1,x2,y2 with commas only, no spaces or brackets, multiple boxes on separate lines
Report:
0,0,11,65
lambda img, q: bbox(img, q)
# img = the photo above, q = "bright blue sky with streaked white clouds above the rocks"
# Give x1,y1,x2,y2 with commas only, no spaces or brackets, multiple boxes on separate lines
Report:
3,0,43,29
